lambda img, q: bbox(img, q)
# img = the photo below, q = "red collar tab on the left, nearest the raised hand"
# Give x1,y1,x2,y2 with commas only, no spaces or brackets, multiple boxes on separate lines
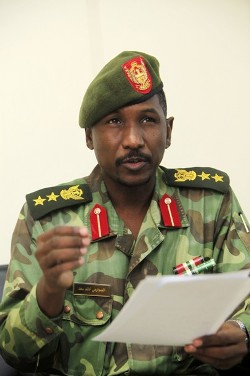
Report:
90,204,109,240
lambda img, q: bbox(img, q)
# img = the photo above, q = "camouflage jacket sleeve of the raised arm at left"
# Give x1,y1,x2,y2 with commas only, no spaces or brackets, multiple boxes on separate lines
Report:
0,205,62,372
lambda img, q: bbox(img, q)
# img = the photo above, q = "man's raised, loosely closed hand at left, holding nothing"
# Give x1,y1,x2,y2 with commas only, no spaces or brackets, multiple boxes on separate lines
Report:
36,226,90,317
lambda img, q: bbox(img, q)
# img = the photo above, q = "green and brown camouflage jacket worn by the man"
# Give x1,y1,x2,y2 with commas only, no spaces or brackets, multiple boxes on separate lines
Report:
0,166,250,376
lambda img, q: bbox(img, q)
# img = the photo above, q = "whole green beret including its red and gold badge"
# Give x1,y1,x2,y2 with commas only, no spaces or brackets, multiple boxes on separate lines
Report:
79,51,163,128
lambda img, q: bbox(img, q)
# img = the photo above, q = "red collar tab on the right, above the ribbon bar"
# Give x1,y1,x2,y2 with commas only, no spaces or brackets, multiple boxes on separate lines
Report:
159,193,181,227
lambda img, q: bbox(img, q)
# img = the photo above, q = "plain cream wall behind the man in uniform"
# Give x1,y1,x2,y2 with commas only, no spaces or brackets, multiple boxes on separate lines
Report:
0,0,250,263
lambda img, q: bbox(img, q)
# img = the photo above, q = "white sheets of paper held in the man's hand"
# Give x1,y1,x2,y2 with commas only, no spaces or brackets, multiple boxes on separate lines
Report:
94,270,250,346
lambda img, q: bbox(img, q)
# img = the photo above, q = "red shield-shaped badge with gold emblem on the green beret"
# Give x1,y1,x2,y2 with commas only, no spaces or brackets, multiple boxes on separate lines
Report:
122,56,152,94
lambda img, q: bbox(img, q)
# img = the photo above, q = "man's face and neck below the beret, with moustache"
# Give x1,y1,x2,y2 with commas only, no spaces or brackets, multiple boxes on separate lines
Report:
86,95,173,238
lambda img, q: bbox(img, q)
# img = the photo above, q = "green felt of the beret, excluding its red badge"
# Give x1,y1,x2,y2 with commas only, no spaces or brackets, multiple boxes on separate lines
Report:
79,51,163,128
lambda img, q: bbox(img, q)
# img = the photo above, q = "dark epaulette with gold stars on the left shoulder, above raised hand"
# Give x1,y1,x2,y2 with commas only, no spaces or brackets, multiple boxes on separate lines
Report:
26,184,92,219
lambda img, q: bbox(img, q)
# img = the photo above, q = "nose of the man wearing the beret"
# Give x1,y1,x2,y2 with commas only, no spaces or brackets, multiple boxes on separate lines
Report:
122,123,144,149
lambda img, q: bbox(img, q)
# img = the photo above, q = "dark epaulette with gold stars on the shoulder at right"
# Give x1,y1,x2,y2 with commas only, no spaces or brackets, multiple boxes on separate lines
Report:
161,166,230,193
